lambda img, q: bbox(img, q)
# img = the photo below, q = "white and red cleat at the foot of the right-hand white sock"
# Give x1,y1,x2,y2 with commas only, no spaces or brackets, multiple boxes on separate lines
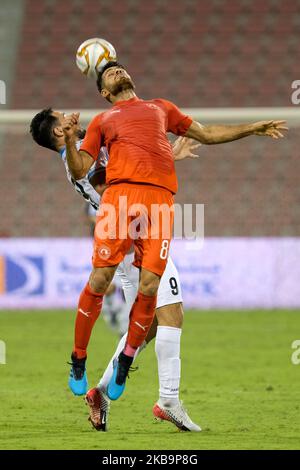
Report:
153,402,201,432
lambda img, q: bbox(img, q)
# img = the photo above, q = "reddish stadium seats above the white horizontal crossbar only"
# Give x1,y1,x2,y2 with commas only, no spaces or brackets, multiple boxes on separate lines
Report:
13,0,299,108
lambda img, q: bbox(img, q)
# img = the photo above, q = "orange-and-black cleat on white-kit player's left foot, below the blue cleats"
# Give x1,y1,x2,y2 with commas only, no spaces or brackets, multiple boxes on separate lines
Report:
85,387,110,432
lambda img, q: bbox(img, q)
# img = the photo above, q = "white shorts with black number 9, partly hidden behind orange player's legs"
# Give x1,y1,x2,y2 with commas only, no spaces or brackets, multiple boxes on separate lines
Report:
116,253,182,308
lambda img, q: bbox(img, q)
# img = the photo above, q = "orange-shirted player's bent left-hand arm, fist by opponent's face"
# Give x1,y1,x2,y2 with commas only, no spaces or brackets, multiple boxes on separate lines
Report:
62,113,94,180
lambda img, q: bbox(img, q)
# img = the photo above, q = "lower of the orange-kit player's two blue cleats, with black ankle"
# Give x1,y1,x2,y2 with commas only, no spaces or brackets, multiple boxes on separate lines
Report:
106,352,133,400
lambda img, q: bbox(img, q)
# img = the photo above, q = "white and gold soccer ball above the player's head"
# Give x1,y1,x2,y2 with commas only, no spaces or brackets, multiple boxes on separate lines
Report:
76,38,117,78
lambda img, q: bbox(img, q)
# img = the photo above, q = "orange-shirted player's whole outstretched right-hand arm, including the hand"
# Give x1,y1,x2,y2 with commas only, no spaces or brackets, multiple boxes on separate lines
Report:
185,121,288,145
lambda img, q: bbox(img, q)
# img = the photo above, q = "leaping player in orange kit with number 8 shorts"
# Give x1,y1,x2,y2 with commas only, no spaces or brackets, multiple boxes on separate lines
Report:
63,62,286,400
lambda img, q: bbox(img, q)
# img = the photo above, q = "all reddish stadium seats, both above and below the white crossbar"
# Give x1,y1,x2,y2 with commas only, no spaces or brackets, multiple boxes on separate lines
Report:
0,0,300,236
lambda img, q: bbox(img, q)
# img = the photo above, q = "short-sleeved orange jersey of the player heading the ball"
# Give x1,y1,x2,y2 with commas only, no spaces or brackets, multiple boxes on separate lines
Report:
80,97,192,194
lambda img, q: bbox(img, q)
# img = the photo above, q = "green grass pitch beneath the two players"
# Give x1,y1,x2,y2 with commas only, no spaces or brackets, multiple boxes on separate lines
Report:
0,311,300,450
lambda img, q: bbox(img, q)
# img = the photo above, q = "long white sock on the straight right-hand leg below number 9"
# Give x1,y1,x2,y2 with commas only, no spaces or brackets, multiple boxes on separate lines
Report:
155,326,181,407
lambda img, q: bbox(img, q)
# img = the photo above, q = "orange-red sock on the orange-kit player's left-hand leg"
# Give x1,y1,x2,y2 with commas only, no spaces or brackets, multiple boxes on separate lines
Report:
73,284,103,359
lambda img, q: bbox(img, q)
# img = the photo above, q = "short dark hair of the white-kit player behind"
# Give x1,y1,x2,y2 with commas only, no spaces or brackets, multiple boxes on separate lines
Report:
30,108,57,151
